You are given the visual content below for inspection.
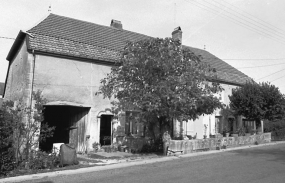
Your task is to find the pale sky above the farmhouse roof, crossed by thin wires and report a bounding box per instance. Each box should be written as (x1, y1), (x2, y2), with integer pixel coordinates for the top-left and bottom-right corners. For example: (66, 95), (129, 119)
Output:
(0, 0), (285, 94)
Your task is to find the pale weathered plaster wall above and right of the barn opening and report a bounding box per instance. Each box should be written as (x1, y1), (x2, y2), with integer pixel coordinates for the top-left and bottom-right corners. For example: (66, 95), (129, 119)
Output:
(31, 55), (111, 148)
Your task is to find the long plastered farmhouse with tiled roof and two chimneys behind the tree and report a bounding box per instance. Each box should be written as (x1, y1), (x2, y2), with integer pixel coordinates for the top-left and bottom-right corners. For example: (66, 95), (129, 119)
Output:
(3, 14), (251, 152)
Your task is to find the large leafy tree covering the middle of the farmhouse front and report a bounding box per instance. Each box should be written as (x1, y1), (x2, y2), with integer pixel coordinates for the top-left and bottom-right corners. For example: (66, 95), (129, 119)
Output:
(98, 38), (222, 136)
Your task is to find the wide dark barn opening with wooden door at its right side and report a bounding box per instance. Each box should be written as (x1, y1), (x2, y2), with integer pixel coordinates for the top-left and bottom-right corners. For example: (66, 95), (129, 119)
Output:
(39, 106), (90, 152)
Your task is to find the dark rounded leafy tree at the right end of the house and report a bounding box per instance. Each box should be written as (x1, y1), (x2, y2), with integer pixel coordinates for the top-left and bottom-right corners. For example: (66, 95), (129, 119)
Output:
(229, 82), (285, 121)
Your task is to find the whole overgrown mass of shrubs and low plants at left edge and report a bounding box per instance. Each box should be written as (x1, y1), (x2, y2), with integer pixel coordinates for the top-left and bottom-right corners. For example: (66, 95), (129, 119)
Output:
(0, 91), (57, 176)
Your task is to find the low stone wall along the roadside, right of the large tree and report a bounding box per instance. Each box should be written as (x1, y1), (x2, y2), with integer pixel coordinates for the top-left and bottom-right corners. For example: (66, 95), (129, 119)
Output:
(168, 133), (271, 154)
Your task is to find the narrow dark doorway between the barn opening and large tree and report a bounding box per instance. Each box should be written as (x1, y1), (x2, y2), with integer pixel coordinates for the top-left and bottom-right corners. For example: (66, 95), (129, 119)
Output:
(100, 115), (113, 145)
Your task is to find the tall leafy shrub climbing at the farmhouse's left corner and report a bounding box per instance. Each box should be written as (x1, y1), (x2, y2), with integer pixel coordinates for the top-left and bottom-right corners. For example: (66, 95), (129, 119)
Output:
(13, 90), (55, 163)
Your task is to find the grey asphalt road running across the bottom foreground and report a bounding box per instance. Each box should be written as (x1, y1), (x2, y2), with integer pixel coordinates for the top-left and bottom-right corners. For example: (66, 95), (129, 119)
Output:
(22, 144), (285, 183)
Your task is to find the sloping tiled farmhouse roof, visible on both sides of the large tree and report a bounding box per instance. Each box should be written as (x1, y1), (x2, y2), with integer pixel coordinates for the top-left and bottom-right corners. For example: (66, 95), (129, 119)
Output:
(27, 14), (250, 84)
